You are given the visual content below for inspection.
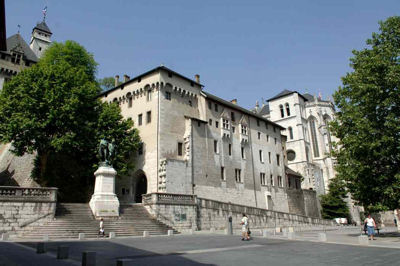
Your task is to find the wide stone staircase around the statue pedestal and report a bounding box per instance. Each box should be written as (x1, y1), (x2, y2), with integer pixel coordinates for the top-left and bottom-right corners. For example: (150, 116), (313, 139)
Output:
(18, 203), (178, 239)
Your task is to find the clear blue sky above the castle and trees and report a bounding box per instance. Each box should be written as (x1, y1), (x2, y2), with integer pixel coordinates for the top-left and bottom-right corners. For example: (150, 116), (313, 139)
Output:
(5, 0), (400, 108)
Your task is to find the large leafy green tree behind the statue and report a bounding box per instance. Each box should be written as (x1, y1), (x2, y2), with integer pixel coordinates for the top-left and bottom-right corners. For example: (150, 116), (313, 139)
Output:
(0, 41), (139, 201)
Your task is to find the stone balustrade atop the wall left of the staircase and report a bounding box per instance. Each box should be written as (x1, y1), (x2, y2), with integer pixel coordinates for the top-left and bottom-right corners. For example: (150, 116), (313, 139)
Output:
(0, 186), (57, 202)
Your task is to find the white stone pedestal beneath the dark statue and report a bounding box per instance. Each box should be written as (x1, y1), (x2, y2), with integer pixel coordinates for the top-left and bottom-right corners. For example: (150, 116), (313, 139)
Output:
(89, 166), (119, 217)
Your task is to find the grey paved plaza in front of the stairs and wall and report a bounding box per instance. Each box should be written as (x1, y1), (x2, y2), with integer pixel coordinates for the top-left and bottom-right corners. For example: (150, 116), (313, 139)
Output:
(0, 228), (400, 266)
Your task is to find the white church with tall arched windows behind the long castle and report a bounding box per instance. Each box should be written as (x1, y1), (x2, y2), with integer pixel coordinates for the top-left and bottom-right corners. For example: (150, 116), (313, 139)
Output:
(254, 90), (336, 194)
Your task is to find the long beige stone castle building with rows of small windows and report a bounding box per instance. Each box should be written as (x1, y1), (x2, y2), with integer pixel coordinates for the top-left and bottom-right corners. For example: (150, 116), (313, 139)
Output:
(100, 66), (320, 217)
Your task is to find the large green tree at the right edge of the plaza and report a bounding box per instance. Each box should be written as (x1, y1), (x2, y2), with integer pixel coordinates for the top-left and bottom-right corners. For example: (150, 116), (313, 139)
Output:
(331, 16), (400, 211)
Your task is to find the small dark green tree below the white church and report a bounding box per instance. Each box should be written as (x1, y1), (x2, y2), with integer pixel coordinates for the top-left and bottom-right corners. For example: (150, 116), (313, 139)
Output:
(320, 177), (350, 219)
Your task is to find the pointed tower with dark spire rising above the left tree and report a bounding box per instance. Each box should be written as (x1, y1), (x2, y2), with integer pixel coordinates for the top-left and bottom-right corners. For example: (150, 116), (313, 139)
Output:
(29, 19), (52, 58)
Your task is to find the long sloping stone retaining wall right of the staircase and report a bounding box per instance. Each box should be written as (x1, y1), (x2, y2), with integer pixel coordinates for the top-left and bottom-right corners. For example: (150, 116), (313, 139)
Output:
(143, 193), (333, 231)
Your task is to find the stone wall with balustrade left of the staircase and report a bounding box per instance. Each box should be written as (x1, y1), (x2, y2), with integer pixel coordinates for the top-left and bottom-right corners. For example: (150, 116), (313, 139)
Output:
(0, 187), (57, 232)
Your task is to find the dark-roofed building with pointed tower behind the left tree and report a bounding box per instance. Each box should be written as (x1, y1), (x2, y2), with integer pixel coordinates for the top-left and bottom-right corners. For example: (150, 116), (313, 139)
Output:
(0, 20), (52, 90)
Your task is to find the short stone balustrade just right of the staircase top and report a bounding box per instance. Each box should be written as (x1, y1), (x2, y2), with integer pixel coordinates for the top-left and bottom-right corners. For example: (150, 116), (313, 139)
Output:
(142, 193), (196, 205)
